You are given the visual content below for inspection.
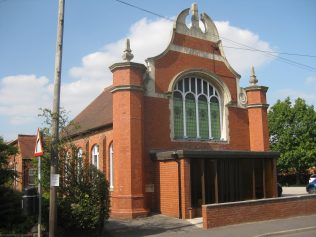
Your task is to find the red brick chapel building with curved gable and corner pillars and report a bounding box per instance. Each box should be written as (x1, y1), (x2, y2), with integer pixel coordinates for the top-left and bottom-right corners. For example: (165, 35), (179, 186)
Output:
(71, 3), (276, 218)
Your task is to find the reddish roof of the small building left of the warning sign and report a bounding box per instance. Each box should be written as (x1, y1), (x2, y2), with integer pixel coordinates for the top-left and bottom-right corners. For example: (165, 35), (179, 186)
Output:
(17, 134), (36, 159)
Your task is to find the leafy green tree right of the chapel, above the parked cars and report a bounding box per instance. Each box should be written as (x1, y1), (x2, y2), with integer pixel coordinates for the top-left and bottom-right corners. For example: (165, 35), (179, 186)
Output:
(268, 97), (316, 182)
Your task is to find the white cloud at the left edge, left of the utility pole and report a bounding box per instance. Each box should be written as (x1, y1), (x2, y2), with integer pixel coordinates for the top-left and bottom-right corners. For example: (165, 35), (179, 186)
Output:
(0, 75), (52, 125)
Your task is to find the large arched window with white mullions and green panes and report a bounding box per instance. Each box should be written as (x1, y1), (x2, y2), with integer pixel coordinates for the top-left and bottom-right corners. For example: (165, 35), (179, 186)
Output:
(173, 77), (222, 140)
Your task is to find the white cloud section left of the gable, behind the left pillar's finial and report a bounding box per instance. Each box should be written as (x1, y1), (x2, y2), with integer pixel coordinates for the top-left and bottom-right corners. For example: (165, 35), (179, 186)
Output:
(61, 18), (172, 115)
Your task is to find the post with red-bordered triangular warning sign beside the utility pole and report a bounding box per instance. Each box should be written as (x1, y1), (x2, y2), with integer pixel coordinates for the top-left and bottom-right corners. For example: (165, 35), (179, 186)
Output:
(34, 129), (43, 237)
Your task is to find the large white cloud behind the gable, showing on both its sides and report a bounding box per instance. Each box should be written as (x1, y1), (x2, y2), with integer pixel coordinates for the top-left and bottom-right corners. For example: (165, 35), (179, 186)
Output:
(62, 18), (272, 114)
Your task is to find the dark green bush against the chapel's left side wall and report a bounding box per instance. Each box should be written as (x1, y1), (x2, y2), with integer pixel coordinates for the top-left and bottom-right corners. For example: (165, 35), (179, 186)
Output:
(58, 164), (109, 231)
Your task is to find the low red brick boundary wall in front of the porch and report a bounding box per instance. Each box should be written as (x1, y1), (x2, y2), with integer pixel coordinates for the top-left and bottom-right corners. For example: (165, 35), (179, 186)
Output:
(202, 194), (316, 229)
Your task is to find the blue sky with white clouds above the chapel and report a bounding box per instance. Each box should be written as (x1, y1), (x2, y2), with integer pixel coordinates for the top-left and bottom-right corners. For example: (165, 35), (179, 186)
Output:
(0, 0), (316, 141)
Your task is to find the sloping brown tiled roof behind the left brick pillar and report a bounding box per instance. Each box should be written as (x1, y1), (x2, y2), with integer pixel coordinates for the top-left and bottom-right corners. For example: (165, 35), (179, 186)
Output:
(67, 86), (113, 136)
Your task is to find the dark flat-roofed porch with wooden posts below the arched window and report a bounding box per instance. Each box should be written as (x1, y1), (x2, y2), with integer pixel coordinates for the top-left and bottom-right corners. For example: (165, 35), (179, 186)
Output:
(151, 150), (280, 208)
